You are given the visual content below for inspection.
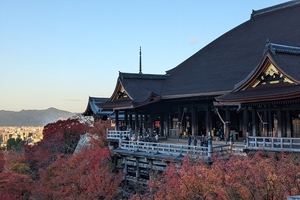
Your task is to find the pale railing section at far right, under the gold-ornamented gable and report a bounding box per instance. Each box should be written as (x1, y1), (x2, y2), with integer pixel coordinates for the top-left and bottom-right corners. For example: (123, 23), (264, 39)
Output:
(246, 136), (300, 152)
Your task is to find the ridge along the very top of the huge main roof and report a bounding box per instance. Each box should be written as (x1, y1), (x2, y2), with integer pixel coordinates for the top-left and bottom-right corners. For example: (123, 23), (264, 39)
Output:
(251, 0), (300, 19)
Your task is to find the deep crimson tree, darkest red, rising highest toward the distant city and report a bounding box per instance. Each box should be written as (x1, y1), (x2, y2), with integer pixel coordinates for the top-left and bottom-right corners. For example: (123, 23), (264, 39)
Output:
(24, 119), (87, 177)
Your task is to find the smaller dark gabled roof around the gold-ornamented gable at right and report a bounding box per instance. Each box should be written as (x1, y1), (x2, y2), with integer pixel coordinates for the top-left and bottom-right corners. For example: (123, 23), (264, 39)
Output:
(216, 41), (300, 102)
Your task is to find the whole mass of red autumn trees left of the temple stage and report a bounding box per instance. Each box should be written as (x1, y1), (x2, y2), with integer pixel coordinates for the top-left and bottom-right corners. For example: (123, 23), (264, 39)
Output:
(0, 119), (122, 200)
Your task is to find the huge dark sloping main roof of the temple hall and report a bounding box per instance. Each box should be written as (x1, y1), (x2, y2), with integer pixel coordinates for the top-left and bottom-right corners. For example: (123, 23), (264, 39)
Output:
(162, 1), (300, 98)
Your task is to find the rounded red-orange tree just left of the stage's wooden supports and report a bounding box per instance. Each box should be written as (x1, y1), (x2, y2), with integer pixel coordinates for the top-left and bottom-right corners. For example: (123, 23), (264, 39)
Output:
(33, 146), (122, 199)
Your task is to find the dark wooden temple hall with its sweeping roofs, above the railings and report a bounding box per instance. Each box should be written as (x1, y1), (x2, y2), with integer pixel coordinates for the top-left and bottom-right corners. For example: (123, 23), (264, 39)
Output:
(83, 0), (300, 142)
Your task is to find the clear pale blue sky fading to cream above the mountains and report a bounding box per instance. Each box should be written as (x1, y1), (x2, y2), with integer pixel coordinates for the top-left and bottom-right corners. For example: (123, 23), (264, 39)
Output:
(0, 0), (286, 112)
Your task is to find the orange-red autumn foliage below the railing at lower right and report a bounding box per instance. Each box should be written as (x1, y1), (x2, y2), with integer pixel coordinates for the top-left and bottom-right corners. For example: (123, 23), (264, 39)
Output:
(132, 152), (300, 200)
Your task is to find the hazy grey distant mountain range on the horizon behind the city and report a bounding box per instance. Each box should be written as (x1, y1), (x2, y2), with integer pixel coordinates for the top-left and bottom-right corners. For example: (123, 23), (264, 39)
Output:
(0, 108), (75, 126)
